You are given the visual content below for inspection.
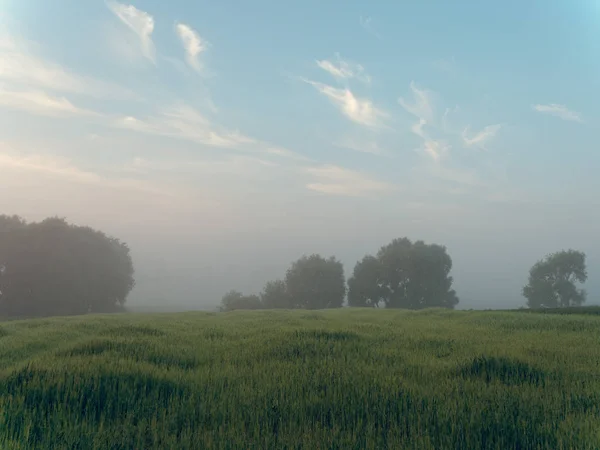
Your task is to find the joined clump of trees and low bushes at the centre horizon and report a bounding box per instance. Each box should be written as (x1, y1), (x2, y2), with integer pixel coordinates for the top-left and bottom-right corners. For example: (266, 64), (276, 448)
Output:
(221, 238), (459, 311)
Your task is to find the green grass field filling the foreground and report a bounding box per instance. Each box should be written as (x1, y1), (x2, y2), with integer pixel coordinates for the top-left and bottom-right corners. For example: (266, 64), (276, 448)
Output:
(0, 309), (600, 450)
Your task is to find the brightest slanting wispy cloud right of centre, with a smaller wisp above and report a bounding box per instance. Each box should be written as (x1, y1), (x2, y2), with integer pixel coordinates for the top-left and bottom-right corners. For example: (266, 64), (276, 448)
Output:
(303, 79), (388, 128)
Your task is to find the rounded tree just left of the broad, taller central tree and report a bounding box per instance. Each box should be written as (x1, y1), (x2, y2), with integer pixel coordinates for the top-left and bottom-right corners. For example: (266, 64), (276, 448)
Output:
(285, 254), (346, 309)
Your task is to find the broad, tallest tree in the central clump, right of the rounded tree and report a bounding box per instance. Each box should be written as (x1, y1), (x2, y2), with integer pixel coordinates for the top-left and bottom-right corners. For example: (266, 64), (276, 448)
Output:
(348, 238), (459, 309)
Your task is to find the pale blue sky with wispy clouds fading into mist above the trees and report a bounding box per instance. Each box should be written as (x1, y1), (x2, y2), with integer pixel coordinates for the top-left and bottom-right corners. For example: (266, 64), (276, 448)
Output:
(0, 0), (600, 308)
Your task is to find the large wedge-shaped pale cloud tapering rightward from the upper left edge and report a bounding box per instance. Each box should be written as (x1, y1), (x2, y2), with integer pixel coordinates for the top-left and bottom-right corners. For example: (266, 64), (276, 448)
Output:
(0, 34), (133, 98)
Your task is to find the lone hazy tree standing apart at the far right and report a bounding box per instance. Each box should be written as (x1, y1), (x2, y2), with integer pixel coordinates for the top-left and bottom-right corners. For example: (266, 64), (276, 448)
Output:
(523, 250), (587, 308)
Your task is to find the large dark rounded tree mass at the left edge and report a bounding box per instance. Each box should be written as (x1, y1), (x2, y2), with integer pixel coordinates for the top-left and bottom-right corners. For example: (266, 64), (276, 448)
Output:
(0, 216), (135, 317)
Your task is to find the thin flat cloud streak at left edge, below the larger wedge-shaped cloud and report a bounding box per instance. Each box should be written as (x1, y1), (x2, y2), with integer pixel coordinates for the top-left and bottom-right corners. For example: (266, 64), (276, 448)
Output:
(0, 86), (98, 117)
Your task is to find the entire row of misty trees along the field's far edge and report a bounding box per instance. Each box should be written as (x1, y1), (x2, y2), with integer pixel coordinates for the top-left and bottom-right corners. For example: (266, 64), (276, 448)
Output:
(0, 215), (587, 317)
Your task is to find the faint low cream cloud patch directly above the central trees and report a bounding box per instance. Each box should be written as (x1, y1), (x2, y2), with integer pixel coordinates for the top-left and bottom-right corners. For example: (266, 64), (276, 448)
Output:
(304, 165), (395, 197)
